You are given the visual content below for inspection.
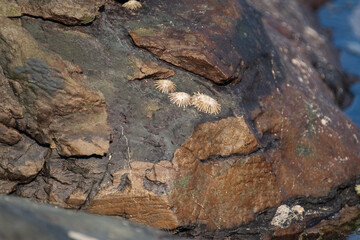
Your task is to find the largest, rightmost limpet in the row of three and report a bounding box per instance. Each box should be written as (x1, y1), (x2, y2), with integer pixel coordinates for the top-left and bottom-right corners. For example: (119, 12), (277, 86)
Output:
(191, 92), (221, 114)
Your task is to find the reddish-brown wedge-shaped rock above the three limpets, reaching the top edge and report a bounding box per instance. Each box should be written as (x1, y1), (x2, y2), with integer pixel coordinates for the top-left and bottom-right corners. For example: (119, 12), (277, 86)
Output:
(130, 0), (246, 83)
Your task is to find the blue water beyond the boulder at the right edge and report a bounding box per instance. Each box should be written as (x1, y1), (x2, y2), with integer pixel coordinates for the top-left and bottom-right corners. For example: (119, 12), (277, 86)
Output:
(319, 0), (360, 126)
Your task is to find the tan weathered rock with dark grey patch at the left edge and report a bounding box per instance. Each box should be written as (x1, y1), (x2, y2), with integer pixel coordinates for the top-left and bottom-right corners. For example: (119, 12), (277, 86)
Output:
(0, 15), (109, 157)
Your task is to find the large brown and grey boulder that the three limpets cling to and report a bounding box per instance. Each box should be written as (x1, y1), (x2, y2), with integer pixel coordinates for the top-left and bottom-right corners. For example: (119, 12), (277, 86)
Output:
(0, 0), (360, 239)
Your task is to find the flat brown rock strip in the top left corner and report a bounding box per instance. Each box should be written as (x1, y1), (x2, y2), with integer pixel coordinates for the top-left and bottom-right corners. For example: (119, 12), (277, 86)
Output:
(0, 0), (106, 25)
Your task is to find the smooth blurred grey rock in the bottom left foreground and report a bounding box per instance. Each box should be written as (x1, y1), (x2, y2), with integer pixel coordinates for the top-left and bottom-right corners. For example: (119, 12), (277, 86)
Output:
(0, 196), (174, 240)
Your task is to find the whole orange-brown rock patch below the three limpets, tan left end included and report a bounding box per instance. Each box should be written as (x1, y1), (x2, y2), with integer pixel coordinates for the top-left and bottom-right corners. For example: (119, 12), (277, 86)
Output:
(87, 117), (281, 230)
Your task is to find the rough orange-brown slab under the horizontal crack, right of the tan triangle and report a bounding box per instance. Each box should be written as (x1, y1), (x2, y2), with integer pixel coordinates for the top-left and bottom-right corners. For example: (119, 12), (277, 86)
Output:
(170, 153), (281, 230)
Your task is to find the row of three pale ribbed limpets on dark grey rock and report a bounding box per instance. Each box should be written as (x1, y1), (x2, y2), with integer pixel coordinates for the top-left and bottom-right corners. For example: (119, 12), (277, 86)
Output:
(155, 80), (221, 115)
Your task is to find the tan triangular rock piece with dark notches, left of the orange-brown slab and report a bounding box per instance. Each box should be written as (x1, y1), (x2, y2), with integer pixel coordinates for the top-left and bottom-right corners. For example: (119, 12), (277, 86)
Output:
(87, 162), (179, 229)
